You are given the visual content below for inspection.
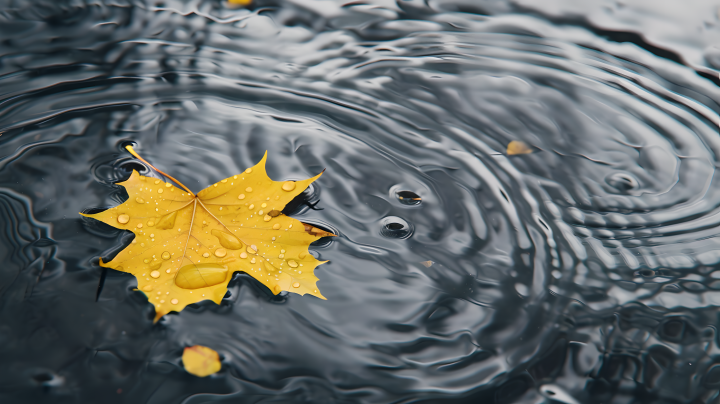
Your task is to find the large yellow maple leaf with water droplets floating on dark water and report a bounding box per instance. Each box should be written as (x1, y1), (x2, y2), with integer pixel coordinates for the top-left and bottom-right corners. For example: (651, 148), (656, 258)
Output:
(81, 146), (334, 321)
